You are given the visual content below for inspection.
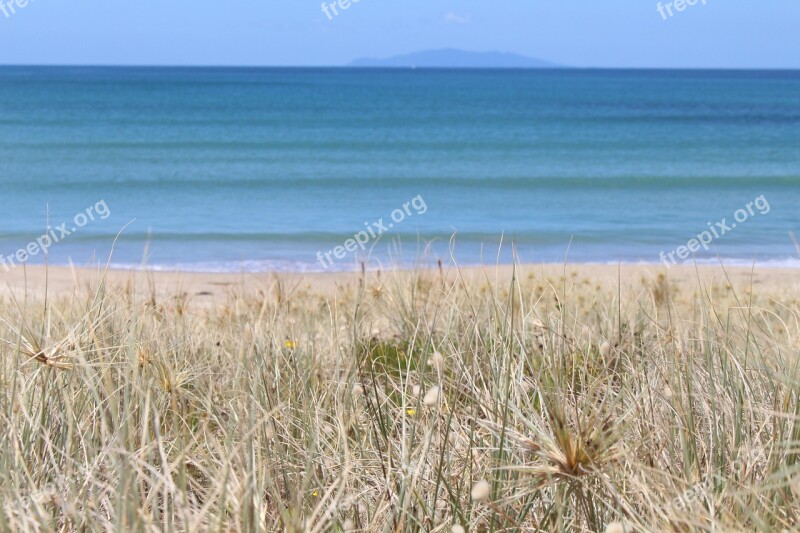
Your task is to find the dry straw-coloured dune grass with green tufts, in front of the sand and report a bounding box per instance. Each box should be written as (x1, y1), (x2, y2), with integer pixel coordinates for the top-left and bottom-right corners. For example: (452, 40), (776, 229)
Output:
(0, 268), (800, 532)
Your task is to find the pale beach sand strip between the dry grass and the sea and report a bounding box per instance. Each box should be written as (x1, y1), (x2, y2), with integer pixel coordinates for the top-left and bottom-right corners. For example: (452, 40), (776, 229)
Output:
(0, 264), (800, 306)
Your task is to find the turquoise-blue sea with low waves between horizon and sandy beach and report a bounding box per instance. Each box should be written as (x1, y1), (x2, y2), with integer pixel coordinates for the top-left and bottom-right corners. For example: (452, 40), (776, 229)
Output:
(0, 67), (800, 271)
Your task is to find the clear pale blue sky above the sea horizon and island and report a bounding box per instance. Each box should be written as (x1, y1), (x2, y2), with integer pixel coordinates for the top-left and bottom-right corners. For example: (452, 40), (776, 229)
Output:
(0, 0), (800, 68)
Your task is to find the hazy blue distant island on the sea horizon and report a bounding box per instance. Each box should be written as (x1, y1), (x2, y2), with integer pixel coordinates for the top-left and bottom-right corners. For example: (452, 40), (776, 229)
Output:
(348, 48), (563, 68)
